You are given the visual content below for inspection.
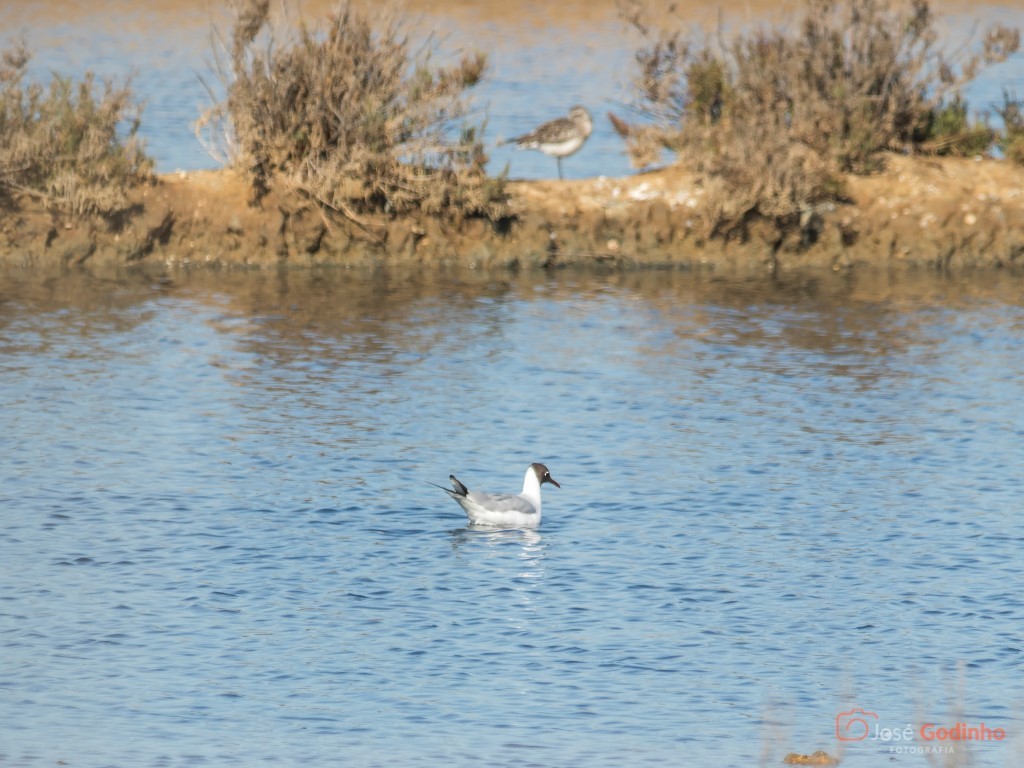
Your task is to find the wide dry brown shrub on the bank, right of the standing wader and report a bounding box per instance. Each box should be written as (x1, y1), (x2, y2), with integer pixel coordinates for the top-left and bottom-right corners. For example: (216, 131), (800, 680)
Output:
(620, 0), (1020, 236)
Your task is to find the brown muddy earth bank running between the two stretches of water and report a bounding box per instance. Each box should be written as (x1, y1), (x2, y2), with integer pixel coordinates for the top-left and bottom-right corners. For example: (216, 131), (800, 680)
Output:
(0, 156), (1024, 271)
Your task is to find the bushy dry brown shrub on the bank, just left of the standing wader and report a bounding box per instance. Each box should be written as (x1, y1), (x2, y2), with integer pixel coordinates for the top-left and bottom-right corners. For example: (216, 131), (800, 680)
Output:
(198, 0), (507, 221)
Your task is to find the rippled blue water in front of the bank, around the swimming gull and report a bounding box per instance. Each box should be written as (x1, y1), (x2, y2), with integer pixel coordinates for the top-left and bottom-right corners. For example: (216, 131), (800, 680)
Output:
(0, 271), (1024, 768)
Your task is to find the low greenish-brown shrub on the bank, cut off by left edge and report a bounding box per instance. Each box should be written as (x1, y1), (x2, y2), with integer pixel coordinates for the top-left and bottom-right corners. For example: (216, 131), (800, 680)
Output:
(0, 43), (153, 217)
